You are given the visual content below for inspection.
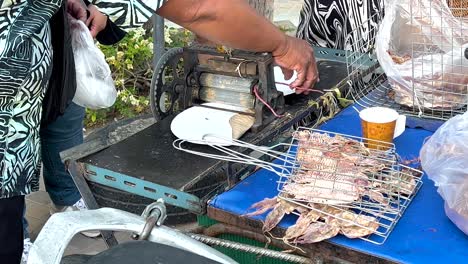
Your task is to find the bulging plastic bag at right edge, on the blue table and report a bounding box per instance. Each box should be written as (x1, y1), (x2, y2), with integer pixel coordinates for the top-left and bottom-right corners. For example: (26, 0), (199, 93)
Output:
(420, 112), (468, 235)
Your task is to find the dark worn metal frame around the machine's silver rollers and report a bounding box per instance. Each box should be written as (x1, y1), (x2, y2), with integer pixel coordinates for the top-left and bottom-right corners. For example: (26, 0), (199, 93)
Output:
(183, 45), (284, 133)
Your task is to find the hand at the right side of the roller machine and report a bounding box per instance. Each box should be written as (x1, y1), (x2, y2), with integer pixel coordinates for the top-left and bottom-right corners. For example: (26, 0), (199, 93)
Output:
(272, 36), (319, 94)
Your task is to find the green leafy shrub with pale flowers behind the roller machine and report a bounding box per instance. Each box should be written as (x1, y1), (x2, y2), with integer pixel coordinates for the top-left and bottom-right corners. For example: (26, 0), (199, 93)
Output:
(85, 27), (193, 128)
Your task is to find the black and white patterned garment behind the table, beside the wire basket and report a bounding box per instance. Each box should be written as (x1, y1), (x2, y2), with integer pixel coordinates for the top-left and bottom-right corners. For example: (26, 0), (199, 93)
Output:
(297, 0), (384, 52)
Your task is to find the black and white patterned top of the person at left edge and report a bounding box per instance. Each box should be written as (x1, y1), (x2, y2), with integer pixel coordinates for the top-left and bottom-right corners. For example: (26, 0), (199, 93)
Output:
(0, 0), (164, 198)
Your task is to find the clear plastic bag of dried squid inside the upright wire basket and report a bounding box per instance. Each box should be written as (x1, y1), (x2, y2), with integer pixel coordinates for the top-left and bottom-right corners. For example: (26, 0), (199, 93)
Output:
(376, 0), (468, 109)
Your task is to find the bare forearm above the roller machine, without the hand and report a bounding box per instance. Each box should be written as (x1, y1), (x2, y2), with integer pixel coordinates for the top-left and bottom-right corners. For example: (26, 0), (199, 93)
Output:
(160, 0), (287, 62)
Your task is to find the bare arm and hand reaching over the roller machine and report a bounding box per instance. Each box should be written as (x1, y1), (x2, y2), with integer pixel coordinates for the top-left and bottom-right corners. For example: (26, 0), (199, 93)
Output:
(156, 0), (318, 92)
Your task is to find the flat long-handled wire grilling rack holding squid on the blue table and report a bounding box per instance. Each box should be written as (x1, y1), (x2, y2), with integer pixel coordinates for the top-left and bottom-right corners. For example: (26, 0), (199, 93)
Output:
(173, 127), (422, 244)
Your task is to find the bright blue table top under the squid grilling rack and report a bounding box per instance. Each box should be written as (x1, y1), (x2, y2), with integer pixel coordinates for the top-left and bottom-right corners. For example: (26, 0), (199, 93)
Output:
(209, 104), (468, 263)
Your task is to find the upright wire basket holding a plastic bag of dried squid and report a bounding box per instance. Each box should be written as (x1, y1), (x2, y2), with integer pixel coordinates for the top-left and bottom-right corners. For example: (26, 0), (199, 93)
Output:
(346, 0), (468, 120)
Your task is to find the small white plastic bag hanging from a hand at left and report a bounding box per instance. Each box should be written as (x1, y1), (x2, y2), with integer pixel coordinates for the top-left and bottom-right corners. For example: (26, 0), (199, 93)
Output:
(70, 19), (117, 109)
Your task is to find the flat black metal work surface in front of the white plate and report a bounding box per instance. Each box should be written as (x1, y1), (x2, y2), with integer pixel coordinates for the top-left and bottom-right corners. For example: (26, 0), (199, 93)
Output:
(81, 117), (221, 189)
